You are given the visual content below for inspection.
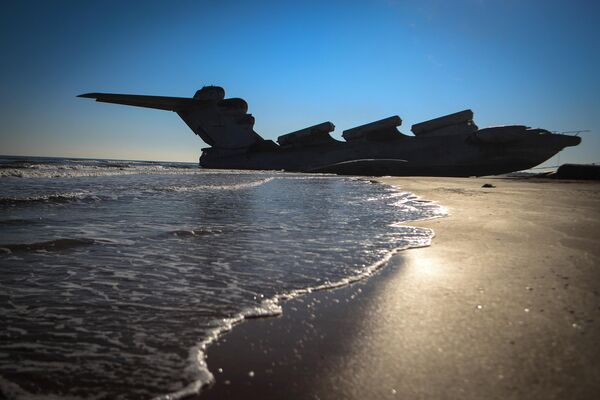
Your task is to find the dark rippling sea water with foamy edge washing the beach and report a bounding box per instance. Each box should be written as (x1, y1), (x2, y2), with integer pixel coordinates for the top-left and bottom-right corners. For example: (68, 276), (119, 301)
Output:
(0, 157), (444, 399)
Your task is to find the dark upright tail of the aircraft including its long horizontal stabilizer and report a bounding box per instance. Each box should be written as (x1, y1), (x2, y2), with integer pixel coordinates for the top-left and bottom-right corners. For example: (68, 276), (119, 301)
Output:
(78, 86), (264, 149)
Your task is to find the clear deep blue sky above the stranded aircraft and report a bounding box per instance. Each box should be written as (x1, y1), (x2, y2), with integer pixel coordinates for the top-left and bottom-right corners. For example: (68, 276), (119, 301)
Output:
(0, 0), (600, 164)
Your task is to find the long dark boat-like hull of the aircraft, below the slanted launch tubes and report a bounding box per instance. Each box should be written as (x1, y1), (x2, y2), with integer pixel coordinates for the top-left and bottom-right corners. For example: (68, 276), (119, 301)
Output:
(200, 126), (581, 176)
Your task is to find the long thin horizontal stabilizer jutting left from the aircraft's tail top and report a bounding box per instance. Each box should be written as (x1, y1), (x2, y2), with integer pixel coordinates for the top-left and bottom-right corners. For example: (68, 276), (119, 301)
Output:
(77, 93), (197, 111)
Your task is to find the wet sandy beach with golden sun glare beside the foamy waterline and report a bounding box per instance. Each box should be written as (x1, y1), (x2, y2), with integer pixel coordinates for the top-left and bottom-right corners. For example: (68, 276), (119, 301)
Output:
(199, 178), (600, 399)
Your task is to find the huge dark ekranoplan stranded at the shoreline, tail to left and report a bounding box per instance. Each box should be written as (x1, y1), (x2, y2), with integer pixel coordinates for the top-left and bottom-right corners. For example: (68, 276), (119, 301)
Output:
(79, 86), (581, 176)
